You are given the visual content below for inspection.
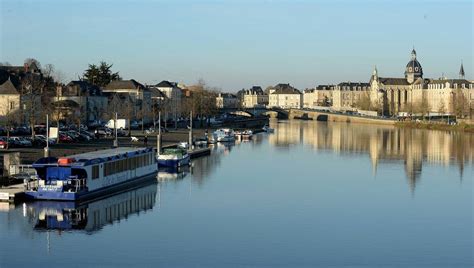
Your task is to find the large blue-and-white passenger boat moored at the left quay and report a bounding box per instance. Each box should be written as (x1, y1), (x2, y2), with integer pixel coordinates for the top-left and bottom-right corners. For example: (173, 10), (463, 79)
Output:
(25, 147), (158, 201)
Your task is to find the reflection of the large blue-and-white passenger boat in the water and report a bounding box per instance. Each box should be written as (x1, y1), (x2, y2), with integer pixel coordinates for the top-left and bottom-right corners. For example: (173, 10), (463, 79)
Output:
(27, 181), (157, 232)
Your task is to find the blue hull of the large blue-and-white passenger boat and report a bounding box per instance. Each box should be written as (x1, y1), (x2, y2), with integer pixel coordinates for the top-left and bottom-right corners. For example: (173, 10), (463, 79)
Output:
(25, 172), (156, 201)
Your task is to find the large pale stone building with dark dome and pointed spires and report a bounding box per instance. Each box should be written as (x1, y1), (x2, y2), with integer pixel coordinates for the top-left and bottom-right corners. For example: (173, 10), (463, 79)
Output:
(369, 49), (474, 117)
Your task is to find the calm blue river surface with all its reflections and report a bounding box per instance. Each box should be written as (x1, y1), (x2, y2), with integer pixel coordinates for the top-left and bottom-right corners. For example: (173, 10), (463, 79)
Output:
(0, 121), (474, 267)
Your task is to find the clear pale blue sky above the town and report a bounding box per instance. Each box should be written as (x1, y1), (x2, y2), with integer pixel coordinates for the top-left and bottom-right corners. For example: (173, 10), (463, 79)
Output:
(0, 0), (474, 92)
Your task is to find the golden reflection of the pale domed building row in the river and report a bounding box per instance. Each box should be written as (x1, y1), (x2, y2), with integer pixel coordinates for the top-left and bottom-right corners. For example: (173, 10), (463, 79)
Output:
(269, 120), (474, 192)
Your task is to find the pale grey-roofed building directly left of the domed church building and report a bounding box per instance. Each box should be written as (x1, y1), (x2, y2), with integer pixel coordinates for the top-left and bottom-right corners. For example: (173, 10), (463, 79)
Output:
(333, 82), (370, 110)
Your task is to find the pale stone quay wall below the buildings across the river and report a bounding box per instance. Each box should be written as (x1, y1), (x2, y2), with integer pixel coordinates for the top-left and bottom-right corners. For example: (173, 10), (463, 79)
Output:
(288, 109), (397, 125)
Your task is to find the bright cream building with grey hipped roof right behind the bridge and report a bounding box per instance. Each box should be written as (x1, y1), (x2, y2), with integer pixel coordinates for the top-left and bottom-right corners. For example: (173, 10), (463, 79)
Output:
(268, 84), (303, 109)
